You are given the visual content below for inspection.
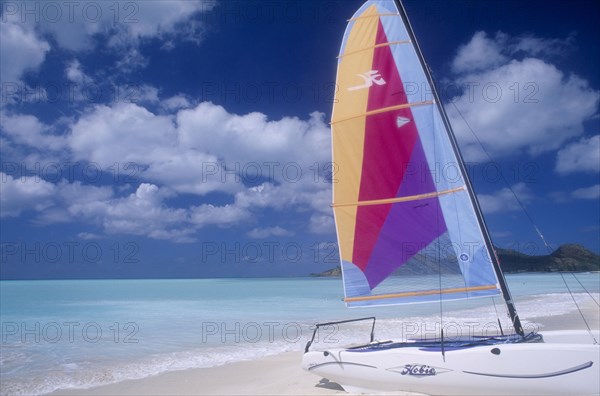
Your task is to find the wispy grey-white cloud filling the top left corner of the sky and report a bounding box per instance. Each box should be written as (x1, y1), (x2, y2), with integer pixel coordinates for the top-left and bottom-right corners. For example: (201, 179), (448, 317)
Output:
(0, 0), (216, 83)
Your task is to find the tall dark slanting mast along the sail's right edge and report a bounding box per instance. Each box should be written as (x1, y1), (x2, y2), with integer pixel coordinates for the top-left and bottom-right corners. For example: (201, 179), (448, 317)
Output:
(394, 0), (525, 336)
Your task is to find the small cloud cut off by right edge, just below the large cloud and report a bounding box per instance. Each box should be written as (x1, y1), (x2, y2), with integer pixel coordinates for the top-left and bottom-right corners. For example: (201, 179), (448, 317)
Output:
(556, 135), (600, 175)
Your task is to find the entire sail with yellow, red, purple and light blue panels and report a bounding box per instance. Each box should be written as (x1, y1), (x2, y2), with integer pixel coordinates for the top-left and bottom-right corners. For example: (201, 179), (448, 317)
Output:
(331, 0), (499, 306)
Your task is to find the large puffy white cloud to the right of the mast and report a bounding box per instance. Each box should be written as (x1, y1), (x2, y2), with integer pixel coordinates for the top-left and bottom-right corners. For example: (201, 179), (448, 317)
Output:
(446, 32), (600, 161)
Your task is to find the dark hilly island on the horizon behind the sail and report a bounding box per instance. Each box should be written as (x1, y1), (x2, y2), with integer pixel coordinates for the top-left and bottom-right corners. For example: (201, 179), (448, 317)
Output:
(310, 244), (600, 277)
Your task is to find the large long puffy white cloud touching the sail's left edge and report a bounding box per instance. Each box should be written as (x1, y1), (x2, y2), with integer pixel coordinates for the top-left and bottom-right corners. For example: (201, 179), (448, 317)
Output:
(67, 102), (330, 200)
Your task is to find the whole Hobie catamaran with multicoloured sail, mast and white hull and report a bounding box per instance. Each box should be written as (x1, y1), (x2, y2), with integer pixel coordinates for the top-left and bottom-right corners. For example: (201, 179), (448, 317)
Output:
(302, 0), (600, 395)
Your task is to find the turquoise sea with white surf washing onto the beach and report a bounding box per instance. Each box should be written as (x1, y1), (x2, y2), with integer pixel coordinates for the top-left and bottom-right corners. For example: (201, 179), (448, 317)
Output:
(0, 273), (600, 395)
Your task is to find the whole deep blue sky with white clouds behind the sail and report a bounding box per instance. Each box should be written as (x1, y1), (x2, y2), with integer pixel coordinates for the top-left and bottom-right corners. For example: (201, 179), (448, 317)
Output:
(0, 0), (600, 279)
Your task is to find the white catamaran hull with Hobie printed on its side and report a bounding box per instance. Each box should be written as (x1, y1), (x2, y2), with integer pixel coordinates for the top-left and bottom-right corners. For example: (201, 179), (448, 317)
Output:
(302, 331), (600, 396)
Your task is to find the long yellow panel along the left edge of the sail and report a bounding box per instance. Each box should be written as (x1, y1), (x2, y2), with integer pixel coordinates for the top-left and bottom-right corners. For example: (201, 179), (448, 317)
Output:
(331, 6), (379, 260)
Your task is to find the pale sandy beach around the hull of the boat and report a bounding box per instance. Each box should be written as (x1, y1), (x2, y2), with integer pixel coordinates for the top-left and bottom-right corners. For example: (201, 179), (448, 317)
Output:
(52, 302), (600, 395)
